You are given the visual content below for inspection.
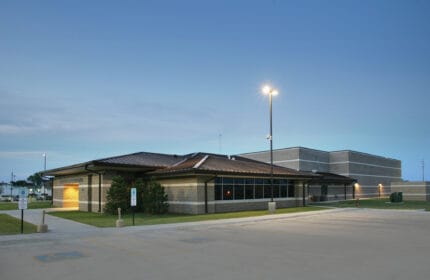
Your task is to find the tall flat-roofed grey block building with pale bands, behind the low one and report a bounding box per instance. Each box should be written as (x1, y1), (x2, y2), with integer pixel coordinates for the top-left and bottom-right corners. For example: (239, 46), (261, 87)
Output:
(240, 147), (402, 200)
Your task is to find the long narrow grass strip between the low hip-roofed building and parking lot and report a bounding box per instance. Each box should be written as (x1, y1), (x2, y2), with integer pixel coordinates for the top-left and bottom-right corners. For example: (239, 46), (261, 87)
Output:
(49, 206), (325, 227)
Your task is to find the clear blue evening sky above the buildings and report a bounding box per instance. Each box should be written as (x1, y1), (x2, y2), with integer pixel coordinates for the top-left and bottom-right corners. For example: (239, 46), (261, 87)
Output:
(0, 0), (430, 181)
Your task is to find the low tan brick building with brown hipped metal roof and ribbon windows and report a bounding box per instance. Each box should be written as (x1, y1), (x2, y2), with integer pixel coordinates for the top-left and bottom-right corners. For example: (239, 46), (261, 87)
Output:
(43, 152), (354, 214)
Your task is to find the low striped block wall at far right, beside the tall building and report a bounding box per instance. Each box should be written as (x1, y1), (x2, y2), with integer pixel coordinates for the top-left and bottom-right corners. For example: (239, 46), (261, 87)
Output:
(391, 182), (430, 201)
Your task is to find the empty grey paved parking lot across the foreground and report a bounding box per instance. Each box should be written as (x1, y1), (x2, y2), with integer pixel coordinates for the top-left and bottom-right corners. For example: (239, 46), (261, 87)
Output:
(0, 209), (430, 280)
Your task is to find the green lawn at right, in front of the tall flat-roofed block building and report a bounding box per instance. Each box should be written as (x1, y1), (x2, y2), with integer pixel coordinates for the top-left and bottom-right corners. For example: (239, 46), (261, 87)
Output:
(312, 198), (430, 211)
